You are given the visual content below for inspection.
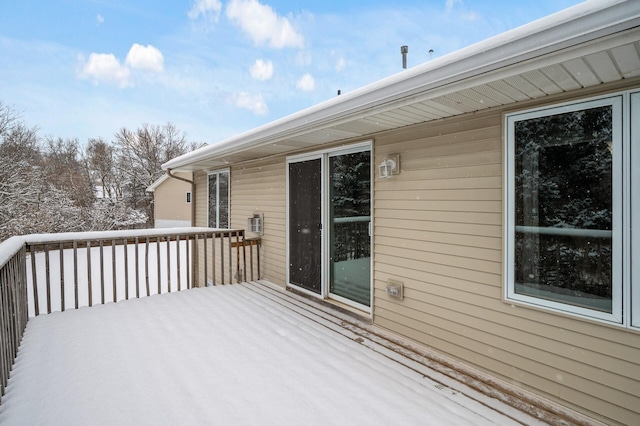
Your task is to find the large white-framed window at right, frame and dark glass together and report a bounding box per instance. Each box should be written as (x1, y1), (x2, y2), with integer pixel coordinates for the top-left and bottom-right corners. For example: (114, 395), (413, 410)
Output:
(505, 93), (640, 326)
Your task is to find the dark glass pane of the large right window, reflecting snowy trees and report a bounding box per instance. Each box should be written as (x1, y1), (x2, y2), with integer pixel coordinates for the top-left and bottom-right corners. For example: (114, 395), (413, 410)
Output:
(514, 106), (613, 312)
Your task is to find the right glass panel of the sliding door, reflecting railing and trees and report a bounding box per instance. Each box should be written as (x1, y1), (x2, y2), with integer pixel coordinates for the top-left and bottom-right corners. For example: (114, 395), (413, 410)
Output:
(329, 151), (371, 306)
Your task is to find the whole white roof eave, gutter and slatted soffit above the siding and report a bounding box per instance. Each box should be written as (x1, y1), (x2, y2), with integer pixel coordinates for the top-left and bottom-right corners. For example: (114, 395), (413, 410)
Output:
(162, 0), (640, 171)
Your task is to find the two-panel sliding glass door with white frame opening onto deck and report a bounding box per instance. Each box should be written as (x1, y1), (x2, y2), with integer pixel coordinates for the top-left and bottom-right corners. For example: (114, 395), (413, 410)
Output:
(288, 143), (371, 308)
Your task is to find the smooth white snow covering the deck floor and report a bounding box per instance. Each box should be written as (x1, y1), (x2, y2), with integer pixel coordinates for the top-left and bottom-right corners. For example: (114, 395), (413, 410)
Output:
(0, 284), (528, 425)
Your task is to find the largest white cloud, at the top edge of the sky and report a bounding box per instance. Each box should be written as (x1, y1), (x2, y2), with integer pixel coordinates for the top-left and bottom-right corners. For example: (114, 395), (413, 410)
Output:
(227, 0), (304, 49)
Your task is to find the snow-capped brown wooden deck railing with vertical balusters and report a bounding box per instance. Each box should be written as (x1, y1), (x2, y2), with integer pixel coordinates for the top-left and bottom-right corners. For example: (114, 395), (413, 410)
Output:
(0, 228), (260, 396)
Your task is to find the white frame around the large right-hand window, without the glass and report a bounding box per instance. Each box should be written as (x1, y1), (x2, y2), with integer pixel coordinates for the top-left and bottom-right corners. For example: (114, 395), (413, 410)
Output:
(504, 93), (624, 326)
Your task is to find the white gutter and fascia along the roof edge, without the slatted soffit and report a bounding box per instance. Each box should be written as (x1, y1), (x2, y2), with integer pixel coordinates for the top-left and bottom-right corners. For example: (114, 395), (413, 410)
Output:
(162, 0), (640, 171)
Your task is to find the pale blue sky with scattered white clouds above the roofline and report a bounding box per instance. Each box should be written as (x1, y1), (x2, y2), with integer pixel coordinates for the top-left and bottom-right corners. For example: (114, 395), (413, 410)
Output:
(0, 0), (579, 144)
